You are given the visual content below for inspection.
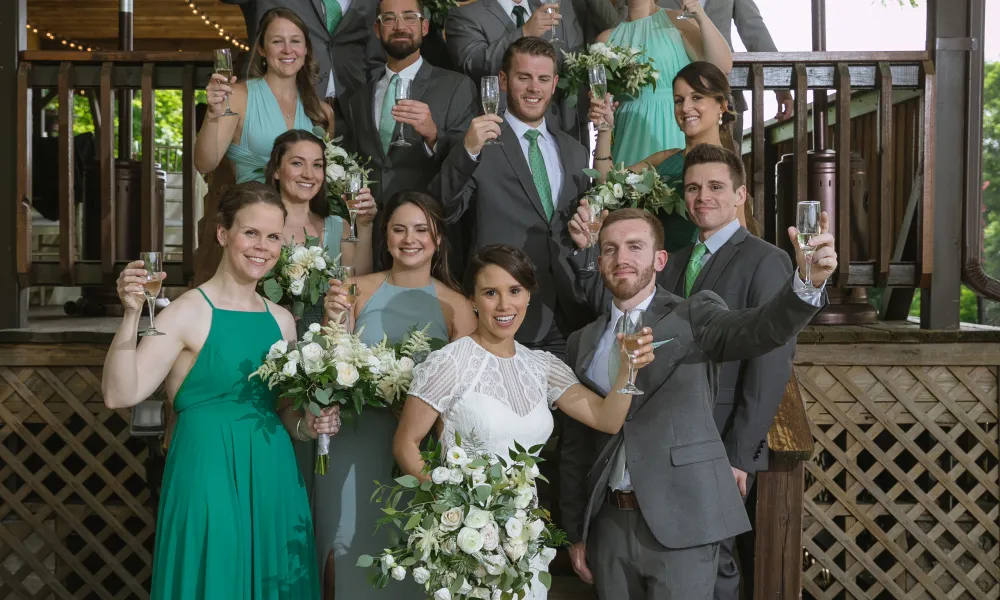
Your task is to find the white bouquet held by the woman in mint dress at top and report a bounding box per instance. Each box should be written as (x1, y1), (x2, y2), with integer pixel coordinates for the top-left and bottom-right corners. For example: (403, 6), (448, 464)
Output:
(559, 42), (660, 105)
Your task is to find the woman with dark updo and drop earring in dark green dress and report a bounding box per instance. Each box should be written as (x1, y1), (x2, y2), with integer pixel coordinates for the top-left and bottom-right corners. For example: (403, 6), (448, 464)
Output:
(590, 61), (756, 252)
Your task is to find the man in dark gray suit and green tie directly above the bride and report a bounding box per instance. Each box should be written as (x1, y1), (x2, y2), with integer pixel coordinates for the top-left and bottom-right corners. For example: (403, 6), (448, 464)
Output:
(430, 37), (593, 356)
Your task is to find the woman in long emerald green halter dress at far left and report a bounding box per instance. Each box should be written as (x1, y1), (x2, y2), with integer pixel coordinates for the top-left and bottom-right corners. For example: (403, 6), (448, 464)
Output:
(103, 182), (338, 600)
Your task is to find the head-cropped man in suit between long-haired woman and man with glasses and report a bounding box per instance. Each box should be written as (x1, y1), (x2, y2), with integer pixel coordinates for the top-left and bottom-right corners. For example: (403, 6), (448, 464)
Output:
(222, 0), (385, 119)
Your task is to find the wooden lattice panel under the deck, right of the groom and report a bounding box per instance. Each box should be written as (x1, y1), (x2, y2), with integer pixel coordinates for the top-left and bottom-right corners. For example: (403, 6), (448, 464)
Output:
(797, 361), (1000, 600)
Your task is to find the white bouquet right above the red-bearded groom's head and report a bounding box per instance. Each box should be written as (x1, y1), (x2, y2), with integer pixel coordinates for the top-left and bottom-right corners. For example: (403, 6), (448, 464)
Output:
(583, 164), (687, 218)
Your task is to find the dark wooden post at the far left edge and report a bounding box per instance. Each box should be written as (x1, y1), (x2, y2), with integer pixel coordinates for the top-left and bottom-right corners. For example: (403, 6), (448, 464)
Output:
(0, 0), (31, 329)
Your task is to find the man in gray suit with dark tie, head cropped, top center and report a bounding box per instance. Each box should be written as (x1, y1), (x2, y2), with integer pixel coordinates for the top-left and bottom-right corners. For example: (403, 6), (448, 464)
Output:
(445, 0), (619, 141)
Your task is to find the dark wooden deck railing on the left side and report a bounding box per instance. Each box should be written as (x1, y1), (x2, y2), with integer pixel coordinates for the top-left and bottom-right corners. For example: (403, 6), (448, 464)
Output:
(17, 51), (212, 286)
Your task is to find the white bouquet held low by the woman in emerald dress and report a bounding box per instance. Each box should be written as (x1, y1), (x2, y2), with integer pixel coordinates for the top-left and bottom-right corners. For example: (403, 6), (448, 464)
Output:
(250, 323), (444, 475)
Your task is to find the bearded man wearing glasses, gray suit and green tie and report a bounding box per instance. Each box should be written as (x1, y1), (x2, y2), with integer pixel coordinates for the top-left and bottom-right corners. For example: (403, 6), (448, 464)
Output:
(341, 0), (477, 267)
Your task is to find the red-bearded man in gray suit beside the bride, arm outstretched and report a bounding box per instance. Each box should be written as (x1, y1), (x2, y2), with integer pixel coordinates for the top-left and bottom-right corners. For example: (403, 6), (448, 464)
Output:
(564, 203), (837, 600)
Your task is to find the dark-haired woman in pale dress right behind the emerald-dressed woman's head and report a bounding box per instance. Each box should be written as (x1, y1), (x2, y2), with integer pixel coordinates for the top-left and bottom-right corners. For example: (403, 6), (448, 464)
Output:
(265, 129), (377, 498)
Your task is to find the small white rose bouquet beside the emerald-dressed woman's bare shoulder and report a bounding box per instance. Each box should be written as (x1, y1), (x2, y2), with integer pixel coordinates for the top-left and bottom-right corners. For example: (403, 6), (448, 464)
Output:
(257, 235), (339, 317)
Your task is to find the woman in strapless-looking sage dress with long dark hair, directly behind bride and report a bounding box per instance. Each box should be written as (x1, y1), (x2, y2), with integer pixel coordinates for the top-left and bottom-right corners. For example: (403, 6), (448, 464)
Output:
(313, 191), (476, 600)
